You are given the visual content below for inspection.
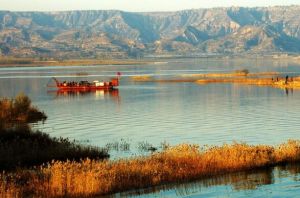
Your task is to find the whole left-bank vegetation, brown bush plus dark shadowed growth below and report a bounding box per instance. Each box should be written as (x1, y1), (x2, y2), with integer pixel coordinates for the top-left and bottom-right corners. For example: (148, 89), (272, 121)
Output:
(0, 94), (109, 170)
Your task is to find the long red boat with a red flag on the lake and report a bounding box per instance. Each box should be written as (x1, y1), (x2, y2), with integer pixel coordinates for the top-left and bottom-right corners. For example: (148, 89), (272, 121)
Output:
(49, 72), (121, 91)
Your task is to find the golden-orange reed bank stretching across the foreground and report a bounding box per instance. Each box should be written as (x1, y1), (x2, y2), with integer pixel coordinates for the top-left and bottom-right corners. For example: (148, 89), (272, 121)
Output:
(0, 140), (300, 196)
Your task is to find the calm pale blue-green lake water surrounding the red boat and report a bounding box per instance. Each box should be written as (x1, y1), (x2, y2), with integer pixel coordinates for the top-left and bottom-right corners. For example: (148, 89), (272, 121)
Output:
(0, 59), (300, 197)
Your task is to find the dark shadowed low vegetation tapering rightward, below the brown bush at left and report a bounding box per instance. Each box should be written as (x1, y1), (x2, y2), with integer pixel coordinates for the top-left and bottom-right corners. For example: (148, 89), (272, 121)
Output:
(0, 127), (109, 170)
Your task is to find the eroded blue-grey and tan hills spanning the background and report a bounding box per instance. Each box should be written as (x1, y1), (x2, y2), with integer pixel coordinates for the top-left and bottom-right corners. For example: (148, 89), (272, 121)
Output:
(0, 6), (300, 58)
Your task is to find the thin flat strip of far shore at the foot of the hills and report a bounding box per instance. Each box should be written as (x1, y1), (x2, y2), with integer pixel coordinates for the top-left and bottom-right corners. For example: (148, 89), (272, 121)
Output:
(0, 54), (300, 68)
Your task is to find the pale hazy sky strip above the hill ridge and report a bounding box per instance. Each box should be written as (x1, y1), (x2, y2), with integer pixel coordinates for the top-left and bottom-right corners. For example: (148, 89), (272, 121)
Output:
(0, 0), (300, 12)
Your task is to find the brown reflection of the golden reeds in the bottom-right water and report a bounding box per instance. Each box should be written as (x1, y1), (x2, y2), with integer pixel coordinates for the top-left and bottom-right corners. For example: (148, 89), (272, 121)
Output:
(114, 163), (300, 197)
